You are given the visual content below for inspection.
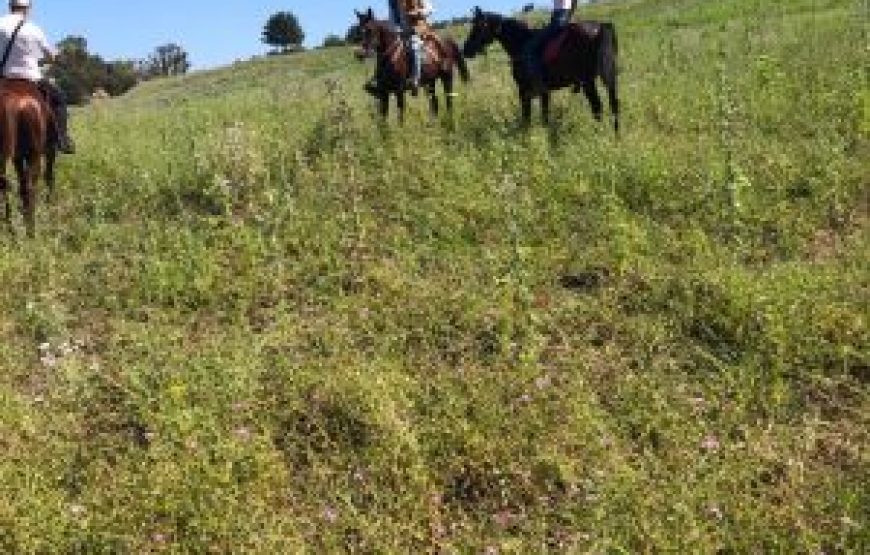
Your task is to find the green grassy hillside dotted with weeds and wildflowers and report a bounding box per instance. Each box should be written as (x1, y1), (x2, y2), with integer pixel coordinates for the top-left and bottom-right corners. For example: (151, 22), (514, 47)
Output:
(0, 0), (870, 553)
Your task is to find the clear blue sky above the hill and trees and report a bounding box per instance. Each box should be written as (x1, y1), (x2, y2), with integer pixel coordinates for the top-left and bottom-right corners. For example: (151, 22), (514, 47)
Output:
(32, 0), (524, 69)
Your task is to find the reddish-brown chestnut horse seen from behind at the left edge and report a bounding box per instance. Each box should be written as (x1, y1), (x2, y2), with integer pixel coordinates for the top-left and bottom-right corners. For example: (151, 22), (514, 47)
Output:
(0, 79), (57, 237)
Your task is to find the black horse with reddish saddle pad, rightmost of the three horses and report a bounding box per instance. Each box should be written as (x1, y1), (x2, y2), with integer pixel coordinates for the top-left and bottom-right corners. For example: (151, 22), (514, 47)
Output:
(463, 8), (619, 133)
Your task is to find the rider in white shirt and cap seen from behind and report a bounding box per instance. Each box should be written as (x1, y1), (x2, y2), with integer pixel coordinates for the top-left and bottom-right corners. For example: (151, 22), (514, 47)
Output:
(0, 0), (75, 154)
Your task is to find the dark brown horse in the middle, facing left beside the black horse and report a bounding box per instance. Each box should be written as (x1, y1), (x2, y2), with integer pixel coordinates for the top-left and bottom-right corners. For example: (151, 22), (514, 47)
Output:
(356, 9), (470, 121)
